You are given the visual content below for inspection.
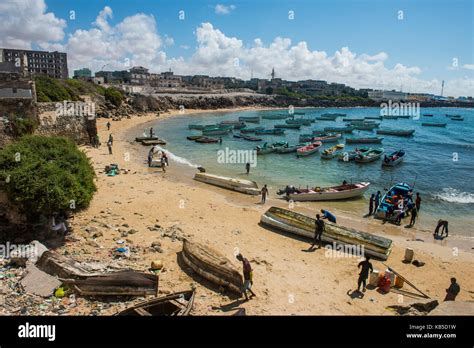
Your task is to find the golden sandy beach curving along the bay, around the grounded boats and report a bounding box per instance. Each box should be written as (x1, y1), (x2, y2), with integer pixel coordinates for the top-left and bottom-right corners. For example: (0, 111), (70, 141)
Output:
(60, 109), (474, 315)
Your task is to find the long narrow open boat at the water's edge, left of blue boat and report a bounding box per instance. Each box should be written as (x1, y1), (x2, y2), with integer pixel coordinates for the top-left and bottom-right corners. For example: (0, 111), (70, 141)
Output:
(287, 182), (370, 201)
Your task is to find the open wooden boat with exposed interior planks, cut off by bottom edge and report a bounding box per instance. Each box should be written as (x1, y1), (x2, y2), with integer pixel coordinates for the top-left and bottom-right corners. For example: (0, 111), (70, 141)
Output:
(115, 290), (195, 317)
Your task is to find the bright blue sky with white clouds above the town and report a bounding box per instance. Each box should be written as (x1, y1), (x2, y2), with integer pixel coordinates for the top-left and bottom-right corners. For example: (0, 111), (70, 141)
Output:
(0, 0), (474, 96)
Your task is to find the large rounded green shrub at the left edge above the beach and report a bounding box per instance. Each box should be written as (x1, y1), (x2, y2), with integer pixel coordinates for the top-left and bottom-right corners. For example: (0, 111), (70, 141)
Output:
(0, 135), (96, 221)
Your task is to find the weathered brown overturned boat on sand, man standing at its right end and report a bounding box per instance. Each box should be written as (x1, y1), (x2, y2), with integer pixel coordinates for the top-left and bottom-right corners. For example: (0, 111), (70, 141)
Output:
(181, 239), (243, 294)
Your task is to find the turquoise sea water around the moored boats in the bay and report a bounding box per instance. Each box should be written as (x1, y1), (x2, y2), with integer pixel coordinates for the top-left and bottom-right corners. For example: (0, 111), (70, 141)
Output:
(142, 108), (474, 236)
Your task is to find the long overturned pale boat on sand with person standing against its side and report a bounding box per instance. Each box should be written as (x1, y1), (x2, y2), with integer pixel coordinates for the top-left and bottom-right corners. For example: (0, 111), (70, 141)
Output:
(260, 207), (392, 260)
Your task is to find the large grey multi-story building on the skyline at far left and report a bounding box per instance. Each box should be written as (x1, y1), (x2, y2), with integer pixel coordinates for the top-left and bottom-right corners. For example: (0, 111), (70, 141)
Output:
(0, 48), (68, 79)
